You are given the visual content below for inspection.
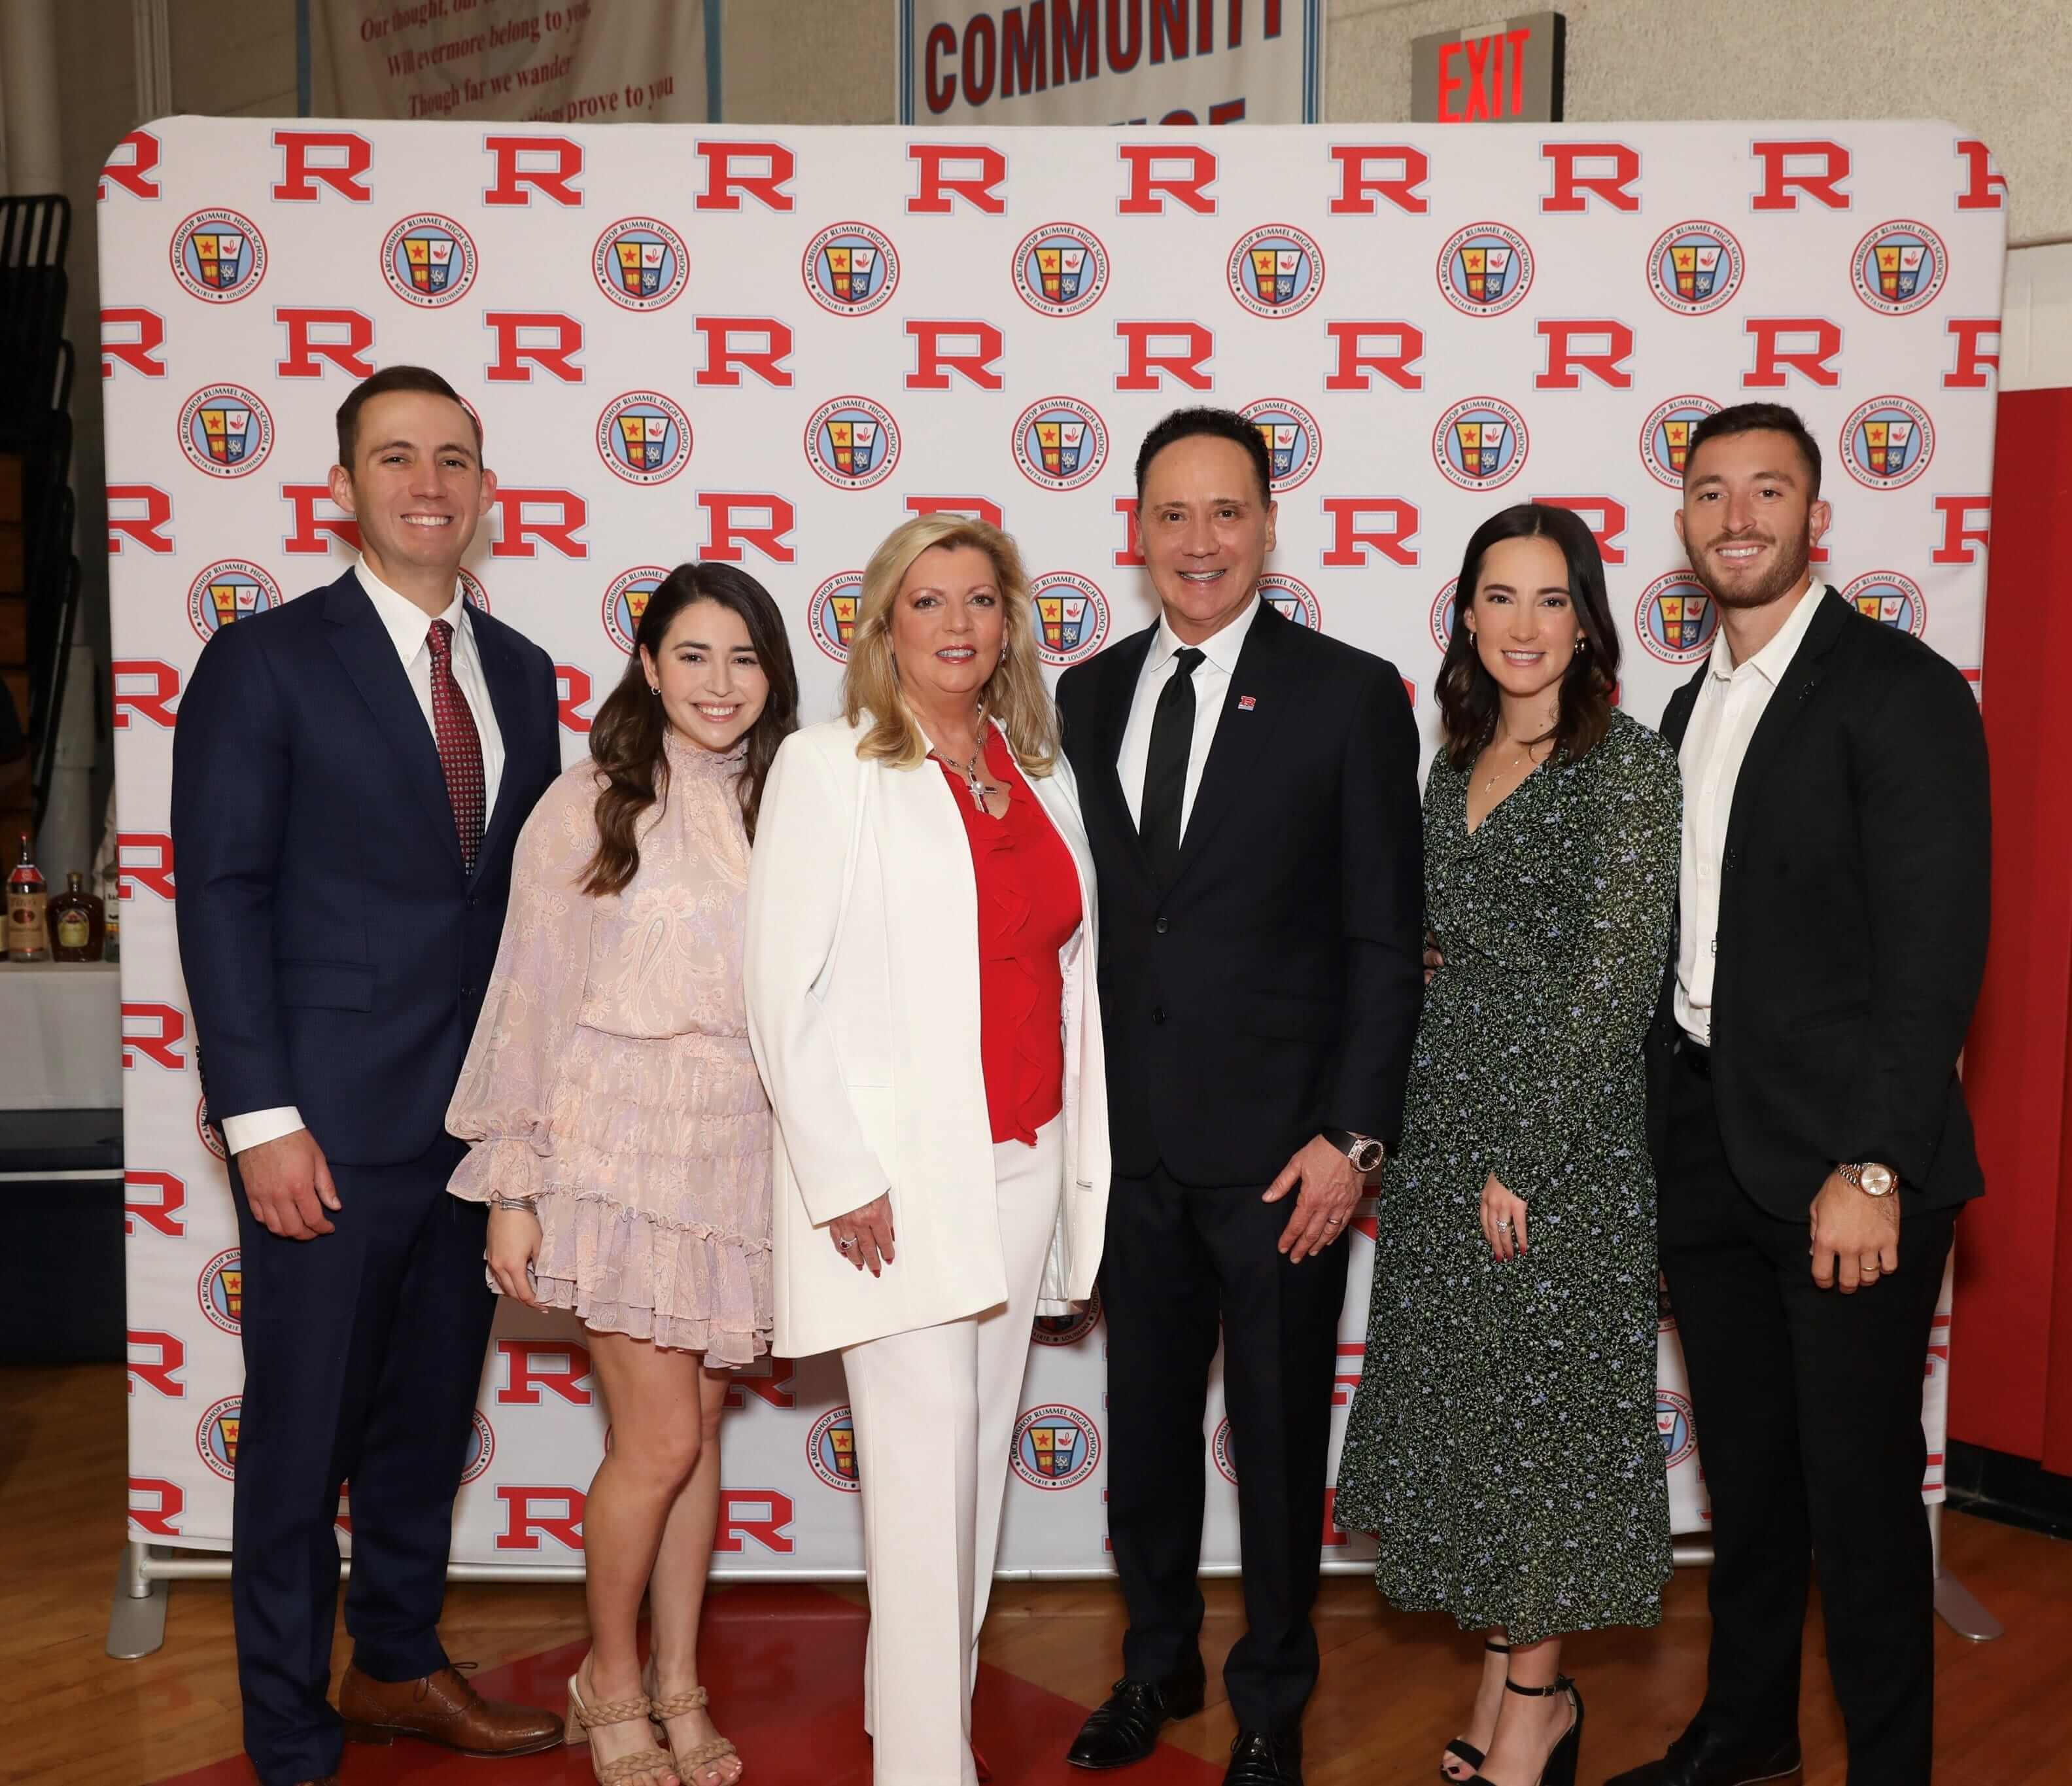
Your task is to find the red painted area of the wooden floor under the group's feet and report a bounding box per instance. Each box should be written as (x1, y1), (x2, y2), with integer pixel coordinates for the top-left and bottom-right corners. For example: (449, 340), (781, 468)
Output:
(158, 1585), (1222, 1786)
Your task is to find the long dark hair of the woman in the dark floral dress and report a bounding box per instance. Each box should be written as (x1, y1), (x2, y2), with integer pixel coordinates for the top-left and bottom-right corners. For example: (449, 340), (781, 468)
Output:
(1438, 501), (1618, 769)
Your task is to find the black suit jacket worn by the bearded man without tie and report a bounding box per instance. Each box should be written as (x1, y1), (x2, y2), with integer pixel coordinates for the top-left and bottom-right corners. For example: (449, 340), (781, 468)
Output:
(1648, 588), (1991, 1220)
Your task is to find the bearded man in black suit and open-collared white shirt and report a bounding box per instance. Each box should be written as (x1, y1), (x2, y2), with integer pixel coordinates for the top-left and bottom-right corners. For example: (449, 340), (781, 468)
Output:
(1614, 404), (1989, 1786)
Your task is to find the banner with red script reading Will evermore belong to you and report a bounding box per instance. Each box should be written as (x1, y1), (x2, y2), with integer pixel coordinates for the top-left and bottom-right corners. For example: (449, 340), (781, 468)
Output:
(309, 0), (704, 124)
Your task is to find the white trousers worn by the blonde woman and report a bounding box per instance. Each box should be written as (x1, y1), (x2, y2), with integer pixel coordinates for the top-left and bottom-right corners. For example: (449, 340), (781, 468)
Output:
(841, 1119), (1065, 1786)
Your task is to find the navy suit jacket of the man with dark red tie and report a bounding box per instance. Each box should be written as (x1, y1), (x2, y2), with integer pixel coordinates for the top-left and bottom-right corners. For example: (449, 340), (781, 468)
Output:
(172, 570), (562, 1164)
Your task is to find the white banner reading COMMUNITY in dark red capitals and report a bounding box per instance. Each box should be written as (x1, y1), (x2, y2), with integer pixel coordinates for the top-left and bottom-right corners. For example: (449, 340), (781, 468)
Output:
(899, 0), (1324, 131)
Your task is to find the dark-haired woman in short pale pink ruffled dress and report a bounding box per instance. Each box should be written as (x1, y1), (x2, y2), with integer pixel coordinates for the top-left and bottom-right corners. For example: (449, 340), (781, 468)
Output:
(445, 563), (798, 1786)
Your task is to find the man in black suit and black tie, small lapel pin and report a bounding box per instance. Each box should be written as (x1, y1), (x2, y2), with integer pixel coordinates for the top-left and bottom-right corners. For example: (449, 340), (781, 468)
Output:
(1057, 408), (1423, 1786)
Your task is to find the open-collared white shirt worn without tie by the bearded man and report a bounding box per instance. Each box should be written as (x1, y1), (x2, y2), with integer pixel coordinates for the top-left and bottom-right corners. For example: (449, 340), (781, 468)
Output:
(1676, 582), (1825, 1049)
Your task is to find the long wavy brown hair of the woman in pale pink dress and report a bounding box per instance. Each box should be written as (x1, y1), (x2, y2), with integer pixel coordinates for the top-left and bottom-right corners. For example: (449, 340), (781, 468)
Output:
(582, 563), (798, 895)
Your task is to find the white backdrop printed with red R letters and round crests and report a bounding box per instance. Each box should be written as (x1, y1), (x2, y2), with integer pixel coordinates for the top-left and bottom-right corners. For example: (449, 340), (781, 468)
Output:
(101, 118), (2003, 1573)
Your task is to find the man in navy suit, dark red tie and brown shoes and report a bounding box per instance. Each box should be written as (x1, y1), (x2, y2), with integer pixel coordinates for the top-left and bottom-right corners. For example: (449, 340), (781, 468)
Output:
(172, 367), (562, 1786)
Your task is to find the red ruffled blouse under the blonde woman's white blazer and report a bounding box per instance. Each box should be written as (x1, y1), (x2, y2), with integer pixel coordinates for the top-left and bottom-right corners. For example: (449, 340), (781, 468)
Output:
(939, 725), (1082, 1146)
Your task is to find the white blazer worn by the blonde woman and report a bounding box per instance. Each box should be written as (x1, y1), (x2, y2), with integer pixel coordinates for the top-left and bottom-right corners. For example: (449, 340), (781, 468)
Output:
(746, 719), (1109, 1357)
